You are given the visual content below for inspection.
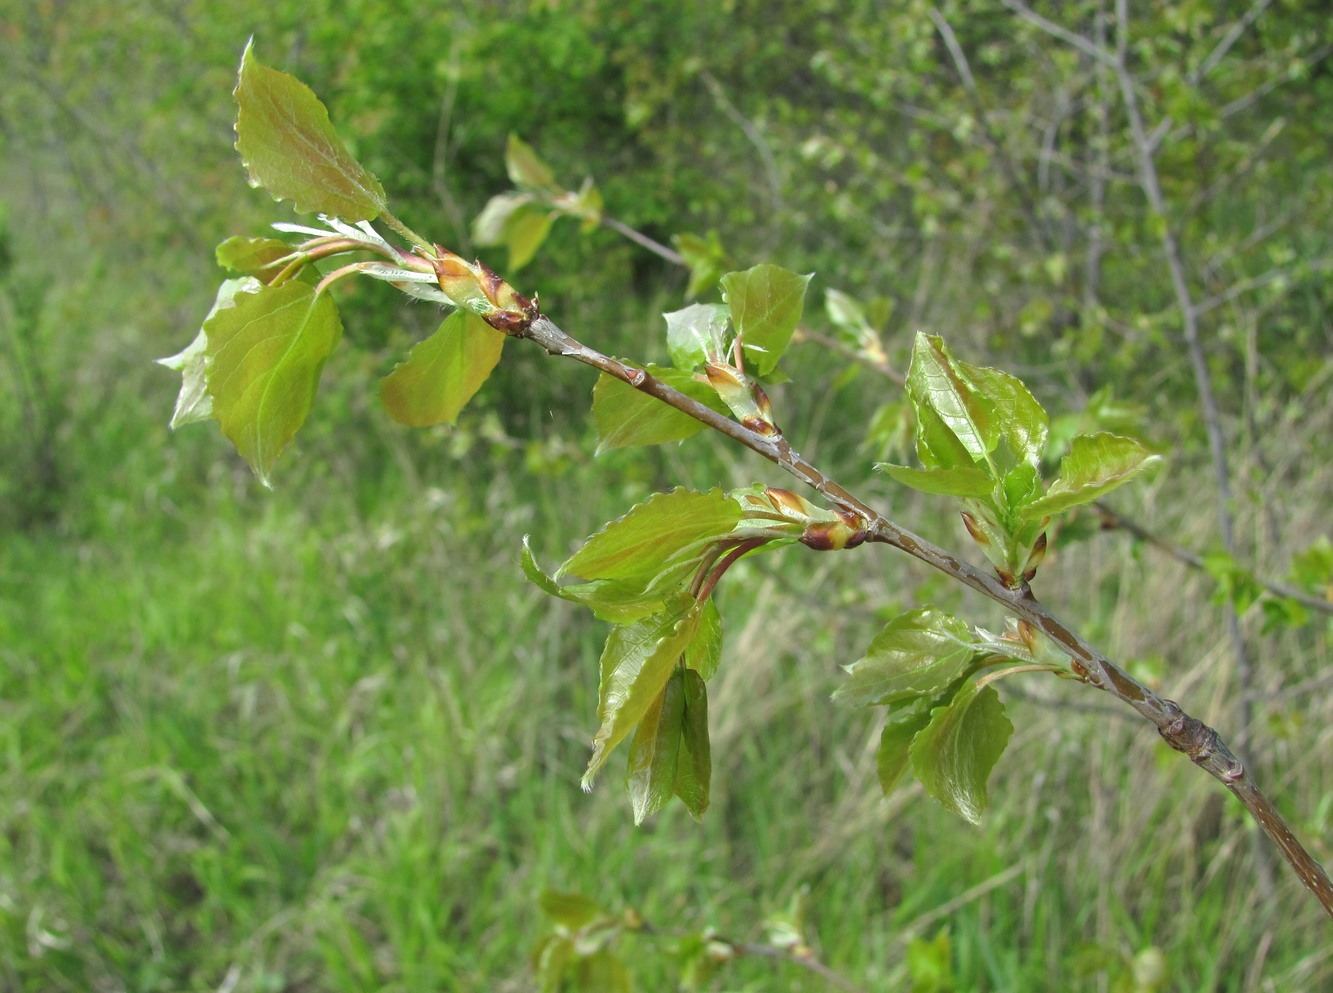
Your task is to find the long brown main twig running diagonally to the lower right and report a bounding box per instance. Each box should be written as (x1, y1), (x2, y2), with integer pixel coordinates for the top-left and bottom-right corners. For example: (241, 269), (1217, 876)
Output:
(500, 309), (1333, 918)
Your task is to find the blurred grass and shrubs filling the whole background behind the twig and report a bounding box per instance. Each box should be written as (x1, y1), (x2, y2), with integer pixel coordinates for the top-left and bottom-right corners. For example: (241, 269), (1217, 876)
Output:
(0, 0), (1333, 990)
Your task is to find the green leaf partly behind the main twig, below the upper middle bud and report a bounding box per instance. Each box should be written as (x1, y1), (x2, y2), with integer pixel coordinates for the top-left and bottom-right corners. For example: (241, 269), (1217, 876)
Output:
(592, 365), (726, 453)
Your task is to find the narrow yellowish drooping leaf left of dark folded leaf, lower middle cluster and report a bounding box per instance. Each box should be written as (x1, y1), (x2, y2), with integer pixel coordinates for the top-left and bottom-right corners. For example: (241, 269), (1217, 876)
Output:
(583, 594), (701, 789)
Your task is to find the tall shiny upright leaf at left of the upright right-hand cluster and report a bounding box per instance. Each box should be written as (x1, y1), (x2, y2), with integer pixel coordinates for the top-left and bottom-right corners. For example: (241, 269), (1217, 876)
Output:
(906, 333), (997, 469)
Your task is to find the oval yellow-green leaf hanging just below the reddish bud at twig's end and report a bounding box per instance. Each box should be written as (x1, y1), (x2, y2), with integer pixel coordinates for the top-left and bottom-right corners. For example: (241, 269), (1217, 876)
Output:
(380, 311), (505, 428)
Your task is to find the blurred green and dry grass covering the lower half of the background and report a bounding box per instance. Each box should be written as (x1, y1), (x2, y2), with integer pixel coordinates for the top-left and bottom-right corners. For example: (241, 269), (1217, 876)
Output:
(0, 359), (1333, 990)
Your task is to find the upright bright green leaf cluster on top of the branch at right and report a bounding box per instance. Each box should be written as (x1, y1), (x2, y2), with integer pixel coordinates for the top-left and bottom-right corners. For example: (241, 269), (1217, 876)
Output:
(878, 333), (1161, 585)
